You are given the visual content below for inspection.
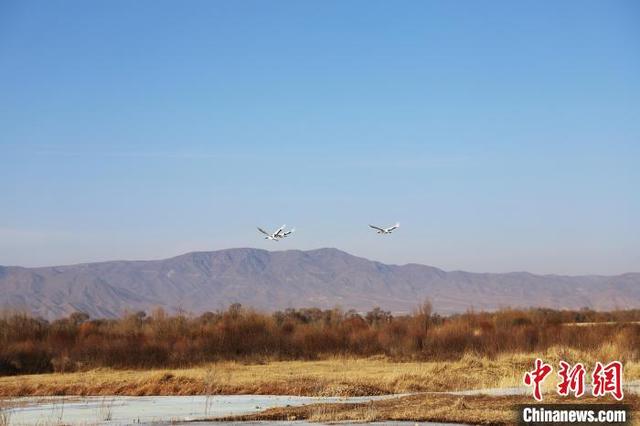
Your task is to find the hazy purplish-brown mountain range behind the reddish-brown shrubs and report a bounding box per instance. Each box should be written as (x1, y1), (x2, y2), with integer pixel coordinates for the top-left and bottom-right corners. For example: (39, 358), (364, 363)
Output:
(0, 248), (640, 319)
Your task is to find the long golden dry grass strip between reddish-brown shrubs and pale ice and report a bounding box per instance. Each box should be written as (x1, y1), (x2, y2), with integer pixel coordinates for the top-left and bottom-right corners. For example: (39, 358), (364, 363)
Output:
(0, 349), (640, 397)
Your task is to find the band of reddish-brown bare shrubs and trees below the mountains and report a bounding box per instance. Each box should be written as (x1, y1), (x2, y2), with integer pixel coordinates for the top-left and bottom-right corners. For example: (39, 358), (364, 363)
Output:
(0, 303), (640, 375)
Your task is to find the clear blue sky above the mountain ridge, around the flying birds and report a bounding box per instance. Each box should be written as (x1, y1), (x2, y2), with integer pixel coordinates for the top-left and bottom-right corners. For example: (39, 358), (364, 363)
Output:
(0, 0), (640, 274)
